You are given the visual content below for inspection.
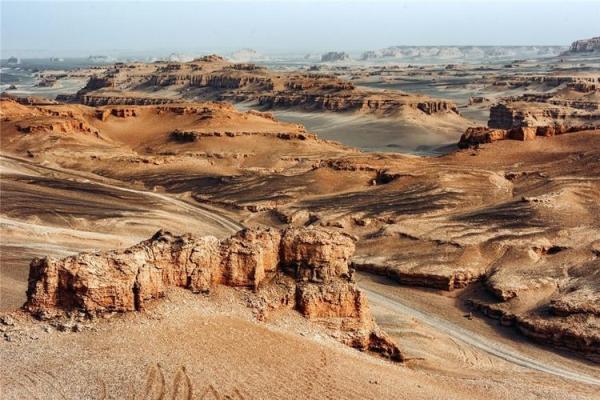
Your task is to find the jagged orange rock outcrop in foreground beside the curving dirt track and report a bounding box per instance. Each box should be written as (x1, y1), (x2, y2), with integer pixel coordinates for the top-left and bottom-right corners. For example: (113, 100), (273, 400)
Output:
(23, 228), (402, 360)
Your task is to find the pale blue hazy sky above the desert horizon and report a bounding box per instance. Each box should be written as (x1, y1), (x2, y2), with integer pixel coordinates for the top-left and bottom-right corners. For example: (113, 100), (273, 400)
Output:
(0, 0), (600, 57)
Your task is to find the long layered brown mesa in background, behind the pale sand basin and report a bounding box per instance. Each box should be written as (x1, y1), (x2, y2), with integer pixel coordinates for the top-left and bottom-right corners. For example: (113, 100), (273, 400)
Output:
(71, 57), (459, 117)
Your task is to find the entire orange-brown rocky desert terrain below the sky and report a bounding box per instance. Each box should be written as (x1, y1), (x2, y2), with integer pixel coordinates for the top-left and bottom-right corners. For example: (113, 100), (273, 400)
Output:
(0, 3), (600, 400)
